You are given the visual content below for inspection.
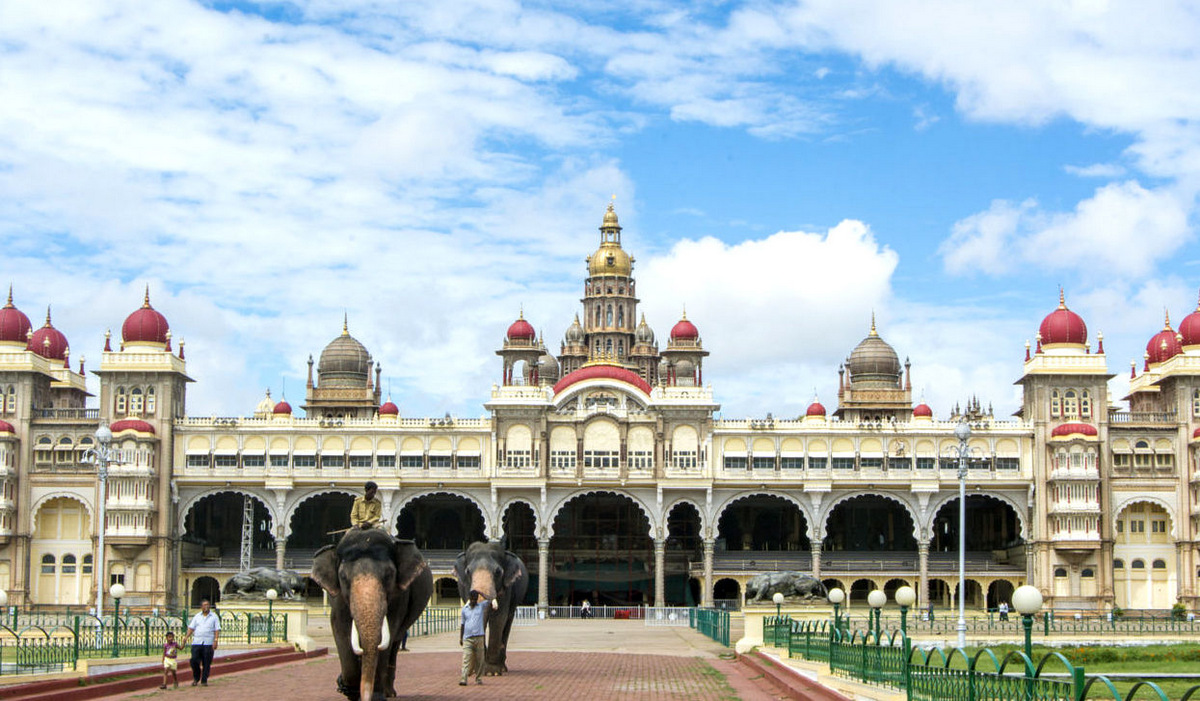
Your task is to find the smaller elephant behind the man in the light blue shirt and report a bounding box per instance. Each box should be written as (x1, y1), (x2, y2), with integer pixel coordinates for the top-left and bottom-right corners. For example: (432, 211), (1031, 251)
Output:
(454, 543), (529, 675)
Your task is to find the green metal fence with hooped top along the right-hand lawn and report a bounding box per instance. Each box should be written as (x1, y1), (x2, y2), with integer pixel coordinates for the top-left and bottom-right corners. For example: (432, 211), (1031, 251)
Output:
(762, 616), (1200, 701)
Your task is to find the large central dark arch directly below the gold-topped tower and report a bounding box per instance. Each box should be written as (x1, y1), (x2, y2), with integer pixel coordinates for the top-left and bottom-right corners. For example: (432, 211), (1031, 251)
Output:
(550, 492), (654, 606)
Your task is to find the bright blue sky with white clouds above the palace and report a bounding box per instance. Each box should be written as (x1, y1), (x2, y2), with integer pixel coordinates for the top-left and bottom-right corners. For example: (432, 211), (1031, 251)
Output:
(0, 0), (1200, 417)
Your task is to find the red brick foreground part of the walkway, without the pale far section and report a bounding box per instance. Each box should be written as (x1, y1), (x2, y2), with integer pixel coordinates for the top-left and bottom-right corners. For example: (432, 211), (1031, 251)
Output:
(105, 651), (781, 701)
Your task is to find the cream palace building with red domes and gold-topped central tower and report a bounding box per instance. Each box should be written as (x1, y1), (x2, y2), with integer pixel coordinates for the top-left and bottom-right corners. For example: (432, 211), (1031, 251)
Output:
(0, 205), (1200, 610)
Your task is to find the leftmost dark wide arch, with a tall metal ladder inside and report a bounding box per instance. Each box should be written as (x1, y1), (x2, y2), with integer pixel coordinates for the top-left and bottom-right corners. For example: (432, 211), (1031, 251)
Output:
(181, 492), (275, 568)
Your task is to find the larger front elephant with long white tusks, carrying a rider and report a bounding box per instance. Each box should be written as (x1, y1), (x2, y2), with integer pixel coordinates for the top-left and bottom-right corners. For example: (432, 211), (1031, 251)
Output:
(312, 528), (433, 701)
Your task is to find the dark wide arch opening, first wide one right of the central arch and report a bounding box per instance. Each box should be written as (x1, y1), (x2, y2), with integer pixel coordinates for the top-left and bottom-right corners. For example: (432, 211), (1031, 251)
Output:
(716, 495), (810, 551)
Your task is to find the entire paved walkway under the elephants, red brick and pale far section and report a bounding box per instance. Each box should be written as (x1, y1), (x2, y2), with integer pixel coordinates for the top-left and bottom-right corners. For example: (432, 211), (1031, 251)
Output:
(105, 621), (782, 701)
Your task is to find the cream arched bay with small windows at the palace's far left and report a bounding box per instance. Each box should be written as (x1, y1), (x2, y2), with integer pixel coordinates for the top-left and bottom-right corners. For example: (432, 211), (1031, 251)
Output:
(30, 497), (96, 605)
